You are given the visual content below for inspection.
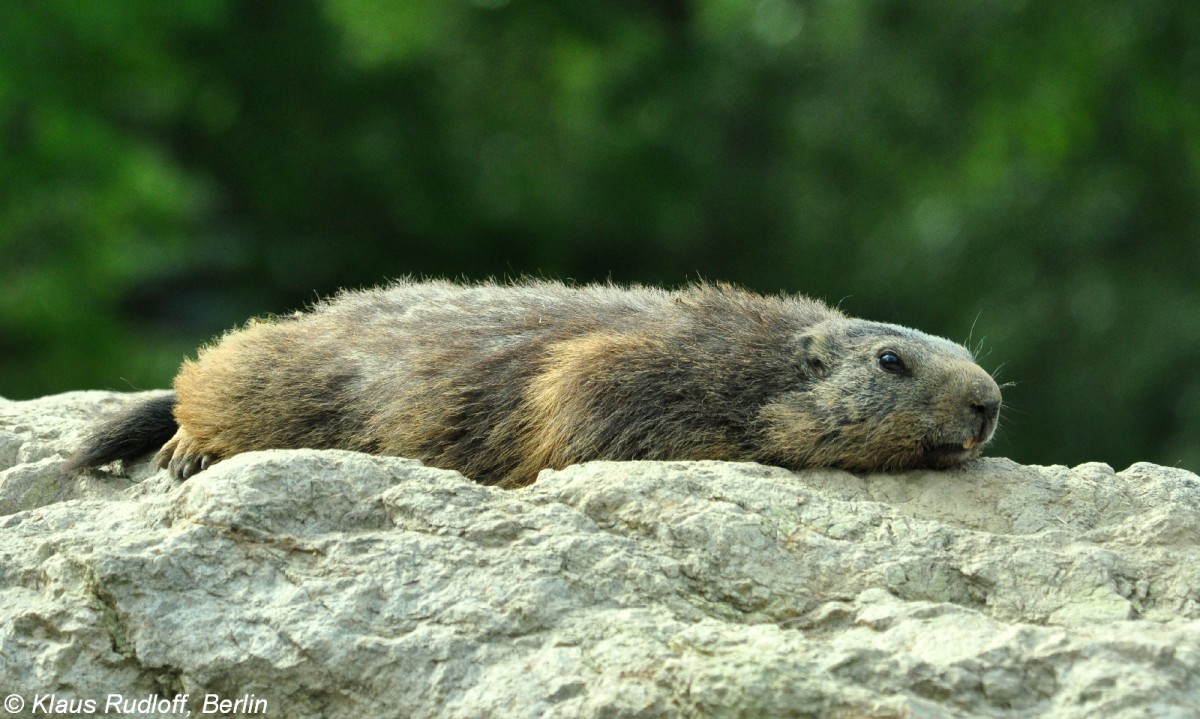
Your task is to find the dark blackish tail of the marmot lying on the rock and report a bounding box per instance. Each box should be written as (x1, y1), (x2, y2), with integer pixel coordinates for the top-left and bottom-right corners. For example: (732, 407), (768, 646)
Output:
(62, 393), (178, 472)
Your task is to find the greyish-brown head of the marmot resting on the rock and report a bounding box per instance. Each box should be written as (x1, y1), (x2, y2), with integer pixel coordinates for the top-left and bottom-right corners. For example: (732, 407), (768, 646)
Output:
(758, 318), (1001, 471)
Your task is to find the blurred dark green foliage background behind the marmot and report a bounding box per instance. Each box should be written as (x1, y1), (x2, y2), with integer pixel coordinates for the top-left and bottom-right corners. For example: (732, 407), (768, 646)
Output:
(0, 0), (1200, 471)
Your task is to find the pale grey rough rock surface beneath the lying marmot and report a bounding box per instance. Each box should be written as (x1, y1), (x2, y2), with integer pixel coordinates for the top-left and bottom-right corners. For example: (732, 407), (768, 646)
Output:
(0, 393), (1200, 719)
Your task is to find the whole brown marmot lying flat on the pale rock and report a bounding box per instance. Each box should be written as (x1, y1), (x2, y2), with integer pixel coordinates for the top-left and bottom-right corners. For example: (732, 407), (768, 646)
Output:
(68, 281), (1001, 487)
